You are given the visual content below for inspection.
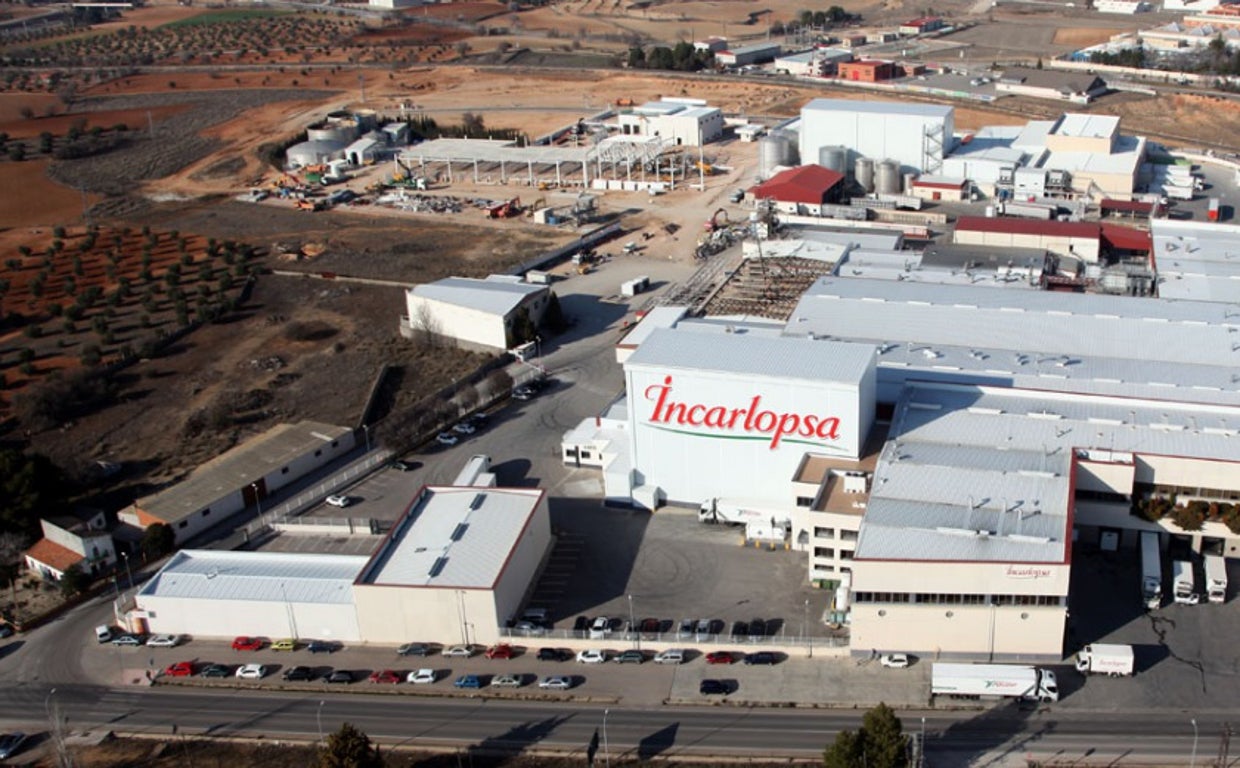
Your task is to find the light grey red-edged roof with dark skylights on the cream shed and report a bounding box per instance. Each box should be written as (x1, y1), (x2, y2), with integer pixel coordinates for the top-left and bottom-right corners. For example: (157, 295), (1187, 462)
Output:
(358, 486), (543, 589)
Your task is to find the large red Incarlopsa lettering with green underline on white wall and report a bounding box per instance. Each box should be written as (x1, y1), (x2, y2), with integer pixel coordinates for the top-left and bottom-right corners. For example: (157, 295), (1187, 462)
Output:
(642, 376), (839, 449)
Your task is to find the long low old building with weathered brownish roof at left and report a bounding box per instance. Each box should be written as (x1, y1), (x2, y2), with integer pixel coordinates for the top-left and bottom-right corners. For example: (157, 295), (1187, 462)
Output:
(118, 421), (356, 543)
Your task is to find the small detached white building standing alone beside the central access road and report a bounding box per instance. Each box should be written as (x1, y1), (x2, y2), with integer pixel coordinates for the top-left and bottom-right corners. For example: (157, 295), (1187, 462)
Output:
(401, 274), (551, 350)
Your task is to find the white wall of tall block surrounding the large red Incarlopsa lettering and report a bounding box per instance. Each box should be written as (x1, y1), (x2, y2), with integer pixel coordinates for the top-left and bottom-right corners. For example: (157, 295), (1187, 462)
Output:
(625, 365), (874, 504)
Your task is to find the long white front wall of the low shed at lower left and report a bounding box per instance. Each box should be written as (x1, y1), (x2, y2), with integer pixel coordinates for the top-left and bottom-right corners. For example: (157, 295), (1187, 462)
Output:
(141, 596), (362, 643)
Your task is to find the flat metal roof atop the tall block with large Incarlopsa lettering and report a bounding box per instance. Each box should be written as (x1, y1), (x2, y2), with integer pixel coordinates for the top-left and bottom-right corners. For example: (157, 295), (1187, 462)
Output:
(625, 329), (874, 385)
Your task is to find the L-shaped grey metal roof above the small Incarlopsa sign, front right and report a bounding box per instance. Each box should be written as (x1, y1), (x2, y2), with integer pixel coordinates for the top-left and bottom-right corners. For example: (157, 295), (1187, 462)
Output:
(856, 383), (1240, 562)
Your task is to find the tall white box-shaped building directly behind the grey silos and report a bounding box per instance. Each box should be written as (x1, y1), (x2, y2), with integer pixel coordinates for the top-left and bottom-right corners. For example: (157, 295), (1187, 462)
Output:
(800, 99), (959, 176)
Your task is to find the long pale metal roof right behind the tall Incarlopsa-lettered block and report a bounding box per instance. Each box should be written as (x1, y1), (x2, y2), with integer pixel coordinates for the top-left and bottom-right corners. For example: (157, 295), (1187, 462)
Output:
(785, 277), (1240, 403)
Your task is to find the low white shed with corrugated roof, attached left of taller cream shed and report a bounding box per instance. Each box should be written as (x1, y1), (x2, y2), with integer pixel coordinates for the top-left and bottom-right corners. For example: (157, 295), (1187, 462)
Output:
(130, 550), (367, 641)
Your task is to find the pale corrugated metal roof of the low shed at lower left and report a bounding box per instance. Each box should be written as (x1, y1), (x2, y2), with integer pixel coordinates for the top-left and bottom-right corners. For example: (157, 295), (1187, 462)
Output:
(138, 550), (367, 605)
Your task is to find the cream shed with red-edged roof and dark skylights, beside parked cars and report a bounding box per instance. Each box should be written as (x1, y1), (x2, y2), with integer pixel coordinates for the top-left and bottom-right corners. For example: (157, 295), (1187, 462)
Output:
(355, 486), (551, 644)
